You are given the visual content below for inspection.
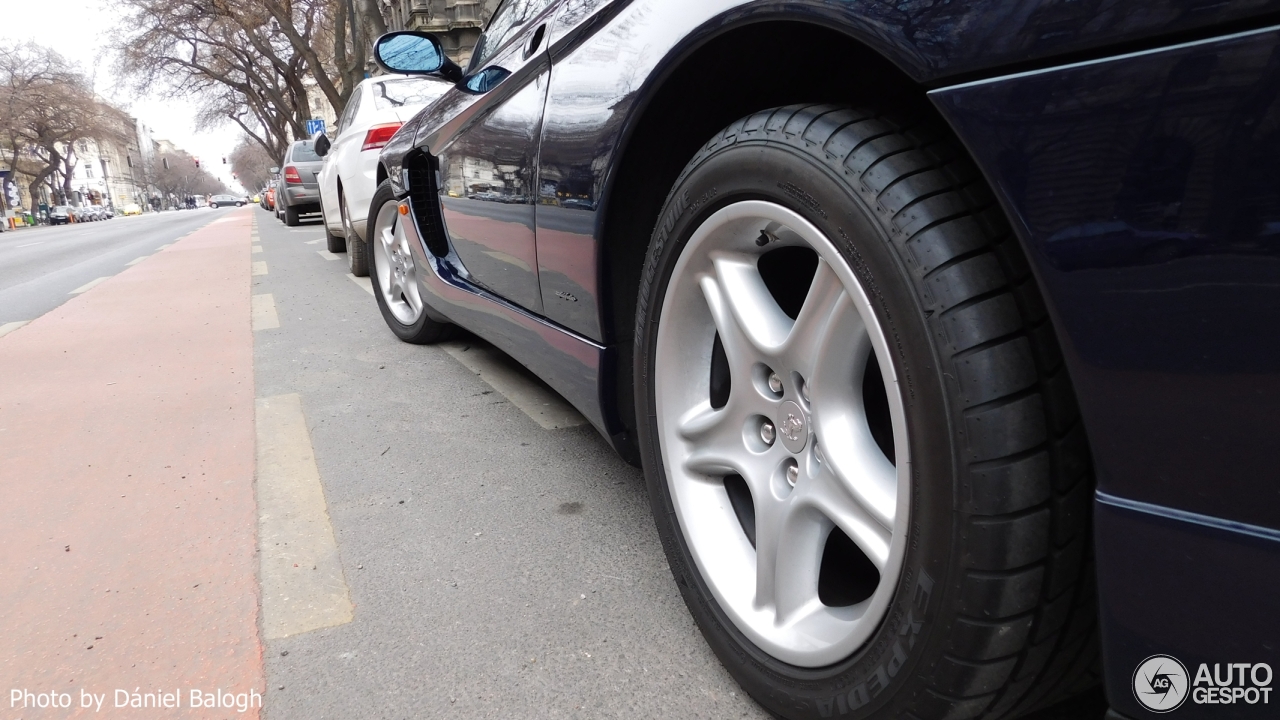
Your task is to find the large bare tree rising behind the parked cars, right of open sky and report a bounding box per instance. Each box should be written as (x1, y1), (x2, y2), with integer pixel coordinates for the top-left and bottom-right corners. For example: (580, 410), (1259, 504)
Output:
(115, 0), (387, 159)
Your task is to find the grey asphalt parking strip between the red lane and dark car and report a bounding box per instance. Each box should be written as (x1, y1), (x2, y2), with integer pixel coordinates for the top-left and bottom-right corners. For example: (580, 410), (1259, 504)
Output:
(252, 210), (767, 720)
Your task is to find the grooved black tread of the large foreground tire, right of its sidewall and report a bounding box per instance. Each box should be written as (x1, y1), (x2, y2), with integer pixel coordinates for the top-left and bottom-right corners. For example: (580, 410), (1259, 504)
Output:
(660, 105), (1100, 720)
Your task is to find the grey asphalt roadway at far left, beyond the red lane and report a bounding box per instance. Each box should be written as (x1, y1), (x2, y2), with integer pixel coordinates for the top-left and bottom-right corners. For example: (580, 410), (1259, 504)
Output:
(0, 208), (229, 325)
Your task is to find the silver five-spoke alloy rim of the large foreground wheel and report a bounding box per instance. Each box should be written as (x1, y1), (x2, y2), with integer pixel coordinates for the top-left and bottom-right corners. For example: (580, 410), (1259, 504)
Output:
(654, 200), (911, 667)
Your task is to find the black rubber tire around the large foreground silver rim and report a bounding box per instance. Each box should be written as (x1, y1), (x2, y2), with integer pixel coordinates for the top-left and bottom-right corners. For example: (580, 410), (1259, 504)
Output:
(635, 105), (1098, 720)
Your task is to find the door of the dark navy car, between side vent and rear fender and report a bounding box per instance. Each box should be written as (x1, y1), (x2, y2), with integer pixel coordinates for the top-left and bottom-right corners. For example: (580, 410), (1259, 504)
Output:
(431, 0), (559, 313)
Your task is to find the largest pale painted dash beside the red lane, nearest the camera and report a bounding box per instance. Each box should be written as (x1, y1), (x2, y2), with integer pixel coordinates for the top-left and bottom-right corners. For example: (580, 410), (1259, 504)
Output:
(255, 393), (355, 641)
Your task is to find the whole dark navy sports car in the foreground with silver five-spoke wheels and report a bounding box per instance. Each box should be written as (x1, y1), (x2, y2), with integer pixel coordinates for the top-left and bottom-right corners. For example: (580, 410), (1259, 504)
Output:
(366, 0), (1280, 720)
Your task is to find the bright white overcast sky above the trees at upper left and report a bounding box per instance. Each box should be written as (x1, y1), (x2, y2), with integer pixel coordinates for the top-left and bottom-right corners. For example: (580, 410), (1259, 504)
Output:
(0, 0), (239, 190)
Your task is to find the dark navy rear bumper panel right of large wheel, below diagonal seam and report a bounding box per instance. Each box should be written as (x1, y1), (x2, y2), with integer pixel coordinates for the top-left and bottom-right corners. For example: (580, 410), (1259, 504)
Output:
(932, 23), (1280, 717)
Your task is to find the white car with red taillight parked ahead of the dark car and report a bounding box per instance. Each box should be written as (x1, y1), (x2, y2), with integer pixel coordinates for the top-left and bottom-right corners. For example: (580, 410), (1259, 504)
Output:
(319, 74), (453, 277)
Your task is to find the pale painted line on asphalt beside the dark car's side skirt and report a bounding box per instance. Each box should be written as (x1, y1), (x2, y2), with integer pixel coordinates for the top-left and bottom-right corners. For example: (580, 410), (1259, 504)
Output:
(436, 341), (586, 430)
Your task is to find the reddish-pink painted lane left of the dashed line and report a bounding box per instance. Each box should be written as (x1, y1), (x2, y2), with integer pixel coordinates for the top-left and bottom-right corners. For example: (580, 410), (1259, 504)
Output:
(0, 209), (265, 717)
